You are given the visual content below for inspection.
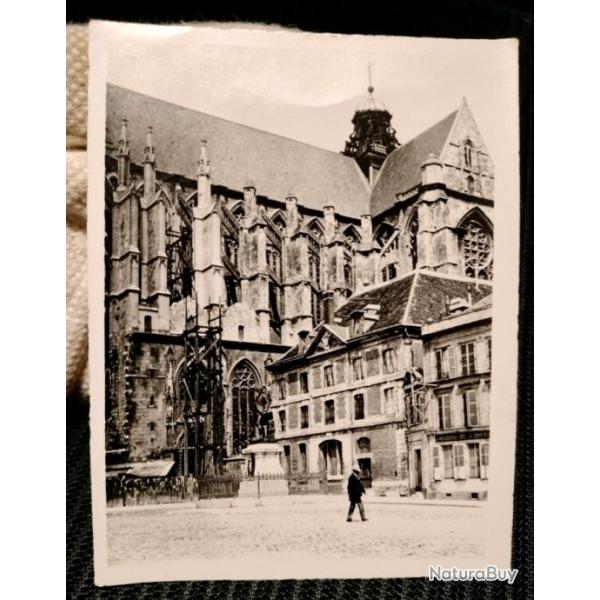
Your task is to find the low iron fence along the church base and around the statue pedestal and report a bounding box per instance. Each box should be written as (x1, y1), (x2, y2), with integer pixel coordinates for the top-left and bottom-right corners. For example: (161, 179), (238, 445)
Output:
(106, 473), (328, 507)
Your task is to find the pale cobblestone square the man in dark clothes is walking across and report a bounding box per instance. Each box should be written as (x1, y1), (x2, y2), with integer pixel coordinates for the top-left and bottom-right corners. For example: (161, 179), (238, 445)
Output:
(108, 496), (485, 578)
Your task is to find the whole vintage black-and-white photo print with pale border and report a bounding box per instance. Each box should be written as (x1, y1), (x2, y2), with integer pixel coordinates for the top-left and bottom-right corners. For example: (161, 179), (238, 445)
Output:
(88, 22), (519, 584)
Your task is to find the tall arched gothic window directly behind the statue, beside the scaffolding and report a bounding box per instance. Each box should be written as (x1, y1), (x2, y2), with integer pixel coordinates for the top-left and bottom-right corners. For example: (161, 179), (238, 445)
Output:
(231, 360), (259, 454)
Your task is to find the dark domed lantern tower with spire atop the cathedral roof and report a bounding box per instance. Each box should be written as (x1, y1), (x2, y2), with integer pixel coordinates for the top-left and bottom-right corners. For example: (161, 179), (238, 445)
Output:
(343, 64), (400, 185)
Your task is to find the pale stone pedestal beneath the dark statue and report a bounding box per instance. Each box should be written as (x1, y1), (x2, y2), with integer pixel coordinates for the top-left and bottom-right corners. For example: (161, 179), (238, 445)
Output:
(238, 443), (288, 497)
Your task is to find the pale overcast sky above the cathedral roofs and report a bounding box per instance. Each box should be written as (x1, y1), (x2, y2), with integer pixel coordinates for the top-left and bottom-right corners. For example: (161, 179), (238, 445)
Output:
(101, 25), (517, 165)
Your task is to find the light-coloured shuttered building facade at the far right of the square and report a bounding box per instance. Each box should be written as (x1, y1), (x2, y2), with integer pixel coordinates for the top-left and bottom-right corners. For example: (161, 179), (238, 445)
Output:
(406, 295), (492, 499)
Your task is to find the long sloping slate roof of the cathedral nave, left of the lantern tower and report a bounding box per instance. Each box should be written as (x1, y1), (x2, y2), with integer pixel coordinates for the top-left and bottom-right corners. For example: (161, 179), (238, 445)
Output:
(106, 84), (370, 217)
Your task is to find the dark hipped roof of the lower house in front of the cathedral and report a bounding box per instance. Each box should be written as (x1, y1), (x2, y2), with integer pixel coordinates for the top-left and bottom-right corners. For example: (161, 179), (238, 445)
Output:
(335, 271), (492, 332)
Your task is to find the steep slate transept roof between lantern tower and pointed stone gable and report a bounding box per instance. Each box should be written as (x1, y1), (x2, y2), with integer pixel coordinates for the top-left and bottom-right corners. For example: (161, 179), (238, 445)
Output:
(371, 110), (458, 216)
